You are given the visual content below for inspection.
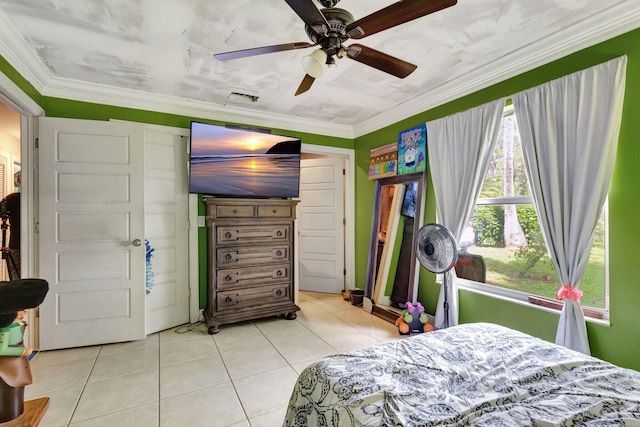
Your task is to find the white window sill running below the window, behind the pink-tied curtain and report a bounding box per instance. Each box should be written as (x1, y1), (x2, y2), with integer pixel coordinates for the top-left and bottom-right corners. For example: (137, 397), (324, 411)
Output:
(458, 278), (610, 326)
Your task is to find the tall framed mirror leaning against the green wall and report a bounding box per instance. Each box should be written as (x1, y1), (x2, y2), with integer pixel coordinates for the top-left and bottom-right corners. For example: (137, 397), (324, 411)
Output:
(365, 172), (426, 322)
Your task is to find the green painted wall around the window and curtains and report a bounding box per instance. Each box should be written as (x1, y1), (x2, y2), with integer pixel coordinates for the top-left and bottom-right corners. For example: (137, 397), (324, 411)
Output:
(355, 30), (640, 370)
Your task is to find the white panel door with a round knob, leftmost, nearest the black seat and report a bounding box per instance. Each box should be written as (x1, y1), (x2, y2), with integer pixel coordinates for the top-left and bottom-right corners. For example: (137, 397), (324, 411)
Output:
(38, 118), (145, 350)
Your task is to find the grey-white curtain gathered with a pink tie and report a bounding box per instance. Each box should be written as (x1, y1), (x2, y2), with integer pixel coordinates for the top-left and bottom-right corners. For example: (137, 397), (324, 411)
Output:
(513, 56), (627, 354)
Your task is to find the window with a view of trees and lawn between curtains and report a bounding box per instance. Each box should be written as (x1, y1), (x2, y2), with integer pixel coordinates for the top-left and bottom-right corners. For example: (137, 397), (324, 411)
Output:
(459, 107), (608, 317)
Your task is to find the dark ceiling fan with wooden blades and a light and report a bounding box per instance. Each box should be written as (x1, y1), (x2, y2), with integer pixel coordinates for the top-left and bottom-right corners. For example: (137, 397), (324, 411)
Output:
(213, 0), (457, 95)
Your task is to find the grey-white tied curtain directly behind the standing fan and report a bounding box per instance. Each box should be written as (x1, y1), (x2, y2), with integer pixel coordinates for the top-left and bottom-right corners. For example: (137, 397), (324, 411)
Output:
(427, 98), (504, 328)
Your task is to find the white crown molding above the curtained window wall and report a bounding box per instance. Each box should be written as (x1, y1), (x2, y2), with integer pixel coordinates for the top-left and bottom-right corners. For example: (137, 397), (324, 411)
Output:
(353, 1), (640, 137)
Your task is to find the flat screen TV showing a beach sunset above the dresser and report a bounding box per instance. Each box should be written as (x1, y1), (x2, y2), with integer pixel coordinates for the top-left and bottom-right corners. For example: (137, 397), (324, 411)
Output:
(189, 122), (301, 198)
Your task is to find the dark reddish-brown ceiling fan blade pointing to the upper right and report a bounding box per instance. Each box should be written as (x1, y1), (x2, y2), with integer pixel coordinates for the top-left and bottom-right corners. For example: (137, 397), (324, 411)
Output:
(346, 0), (457, 39)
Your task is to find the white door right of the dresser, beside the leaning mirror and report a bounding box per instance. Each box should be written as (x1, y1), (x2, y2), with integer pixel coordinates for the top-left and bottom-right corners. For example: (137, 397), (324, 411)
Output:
(298, 157), (345, 293)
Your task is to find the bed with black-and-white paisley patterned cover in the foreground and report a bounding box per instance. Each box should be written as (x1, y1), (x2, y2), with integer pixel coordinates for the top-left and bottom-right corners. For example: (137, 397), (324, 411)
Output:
(284, 323), (640, 427)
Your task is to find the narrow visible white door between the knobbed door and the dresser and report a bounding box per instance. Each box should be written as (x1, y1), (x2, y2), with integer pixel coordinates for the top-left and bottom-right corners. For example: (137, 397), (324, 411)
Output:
(144, 128), (190, 334)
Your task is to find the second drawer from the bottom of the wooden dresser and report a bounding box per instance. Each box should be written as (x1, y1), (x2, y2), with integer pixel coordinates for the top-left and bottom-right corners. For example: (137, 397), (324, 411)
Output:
(216, 263), (291, 291)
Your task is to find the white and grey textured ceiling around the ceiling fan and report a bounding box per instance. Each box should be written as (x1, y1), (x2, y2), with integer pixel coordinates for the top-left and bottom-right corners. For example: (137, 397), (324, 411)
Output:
(0, 0), (640, 134)
